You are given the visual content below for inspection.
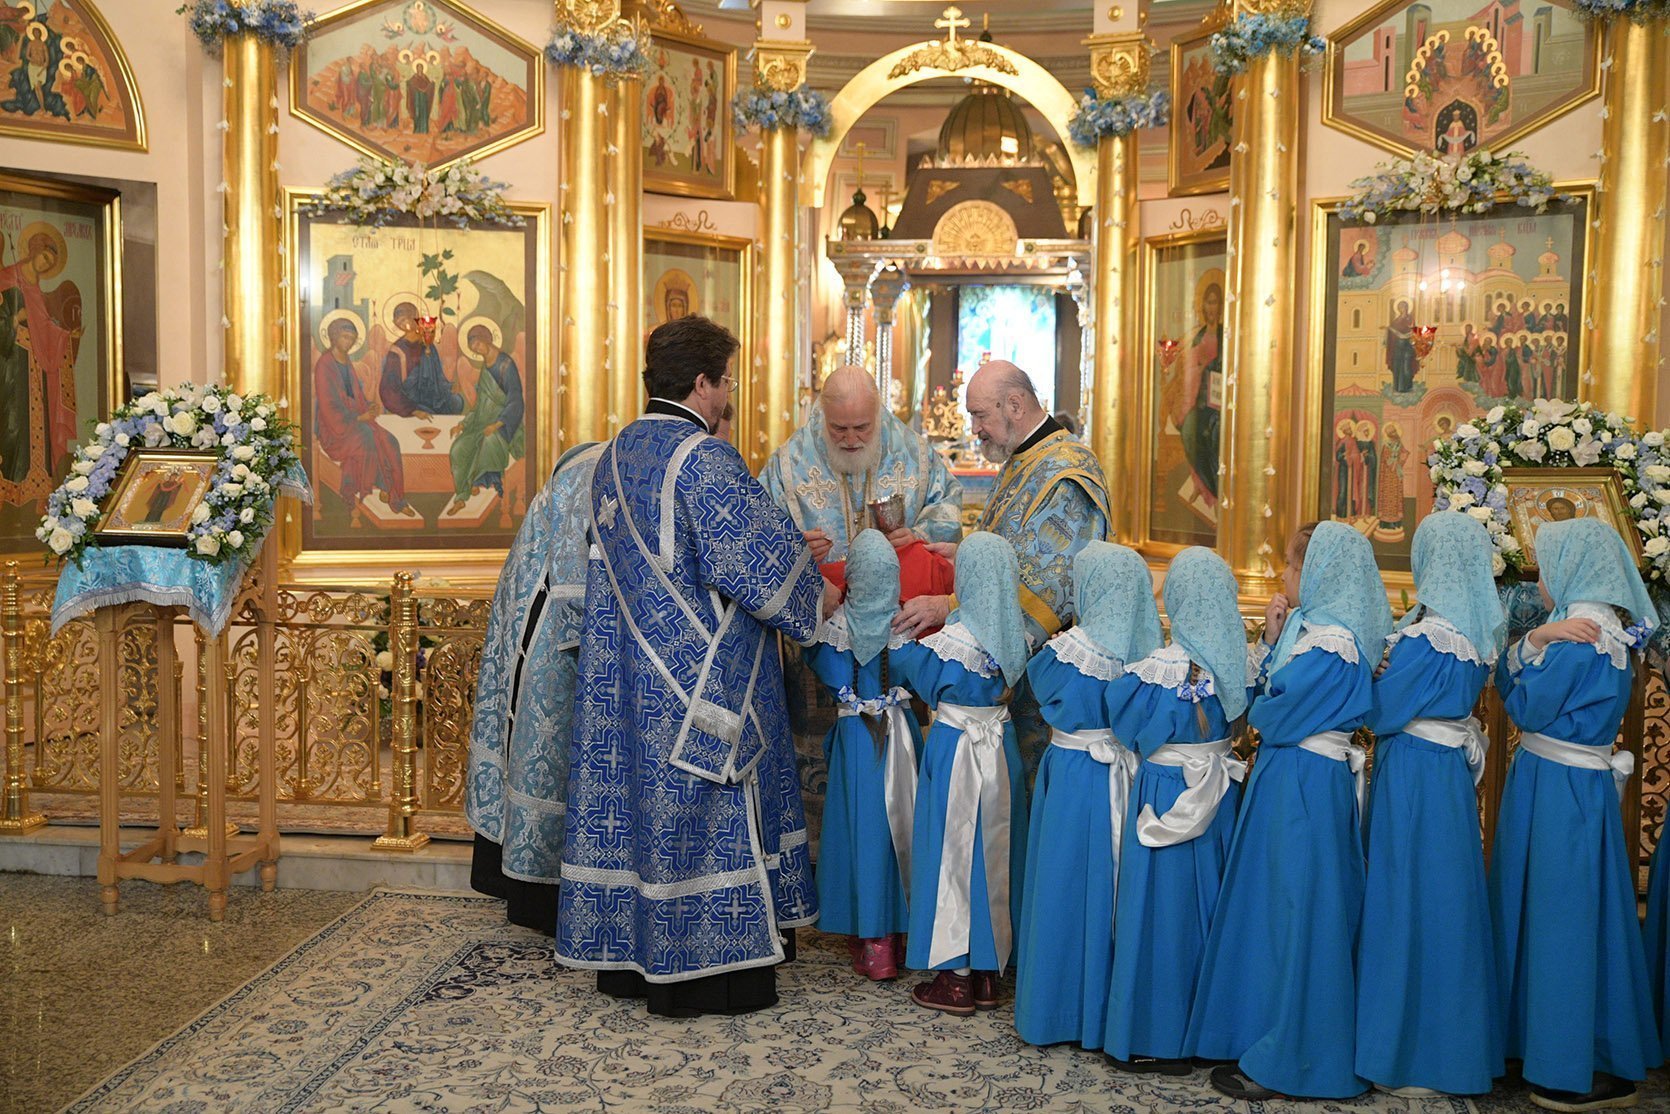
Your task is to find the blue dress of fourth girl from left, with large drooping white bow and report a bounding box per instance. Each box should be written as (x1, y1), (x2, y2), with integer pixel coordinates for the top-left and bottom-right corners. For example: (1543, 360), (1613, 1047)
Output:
(1102, 654), (1241, 1061)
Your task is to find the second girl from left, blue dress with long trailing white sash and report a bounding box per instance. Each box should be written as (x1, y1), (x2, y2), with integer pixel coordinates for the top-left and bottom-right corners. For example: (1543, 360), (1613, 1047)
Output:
(890, 531), (1029, 1015)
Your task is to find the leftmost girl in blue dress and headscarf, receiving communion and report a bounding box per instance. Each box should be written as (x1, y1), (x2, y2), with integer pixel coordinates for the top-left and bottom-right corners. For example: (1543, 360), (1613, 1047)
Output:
(805, 529), (922, 980)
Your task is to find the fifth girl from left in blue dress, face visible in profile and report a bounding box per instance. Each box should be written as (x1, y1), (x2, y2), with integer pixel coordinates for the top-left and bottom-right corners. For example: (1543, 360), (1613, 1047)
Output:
(1187, 523), (1391, 1099)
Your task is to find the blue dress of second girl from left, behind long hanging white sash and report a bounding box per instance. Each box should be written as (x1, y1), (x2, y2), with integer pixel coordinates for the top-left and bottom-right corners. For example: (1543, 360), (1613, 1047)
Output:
(890, 626), (1027, 970)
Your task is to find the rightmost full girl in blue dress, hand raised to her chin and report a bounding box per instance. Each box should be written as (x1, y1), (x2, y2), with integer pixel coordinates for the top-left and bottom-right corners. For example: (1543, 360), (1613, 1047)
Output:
(1490, 518), (1662, 1111)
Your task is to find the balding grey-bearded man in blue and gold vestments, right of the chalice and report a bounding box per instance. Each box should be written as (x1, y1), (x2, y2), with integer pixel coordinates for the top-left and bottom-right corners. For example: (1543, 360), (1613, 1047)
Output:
(893, 359), (1109, 772)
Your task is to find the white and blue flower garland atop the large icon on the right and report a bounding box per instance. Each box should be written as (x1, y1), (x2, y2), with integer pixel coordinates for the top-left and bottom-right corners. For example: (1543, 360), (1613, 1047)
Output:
(1339, 147), (1568, 224)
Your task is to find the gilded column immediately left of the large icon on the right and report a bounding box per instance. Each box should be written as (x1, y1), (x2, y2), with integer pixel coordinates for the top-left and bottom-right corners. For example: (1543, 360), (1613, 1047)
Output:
(1217, 0), (1309, 595)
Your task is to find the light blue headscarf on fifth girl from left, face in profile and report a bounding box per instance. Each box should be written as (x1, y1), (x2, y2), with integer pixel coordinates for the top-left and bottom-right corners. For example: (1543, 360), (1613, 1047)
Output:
(1269, 523), (1391, 673)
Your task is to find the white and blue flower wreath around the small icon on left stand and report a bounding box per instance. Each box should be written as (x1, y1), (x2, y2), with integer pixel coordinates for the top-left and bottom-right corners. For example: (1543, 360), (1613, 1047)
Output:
(35, 384), (304, 565)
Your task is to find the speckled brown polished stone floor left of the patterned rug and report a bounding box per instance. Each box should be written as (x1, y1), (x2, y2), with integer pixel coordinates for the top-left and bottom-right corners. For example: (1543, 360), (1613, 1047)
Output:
(0, 873), (366, 1114)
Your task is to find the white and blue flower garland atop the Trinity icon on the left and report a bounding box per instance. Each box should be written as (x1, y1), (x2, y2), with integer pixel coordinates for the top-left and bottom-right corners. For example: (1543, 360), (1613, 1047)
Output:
(306, 157), (524, 229)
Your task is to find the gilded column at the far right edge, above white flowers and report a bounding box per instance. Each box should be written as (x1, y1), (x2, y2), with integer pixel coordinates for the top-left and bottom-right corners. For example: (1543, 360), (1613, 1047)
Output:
(1581, 17), (1670, 426)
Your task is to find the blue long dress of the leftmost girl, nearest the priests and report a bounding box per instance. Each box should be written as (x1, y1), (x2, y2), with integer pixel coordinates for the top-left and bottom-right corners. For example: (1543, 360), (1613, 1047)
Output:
(803, 611), (922, 940)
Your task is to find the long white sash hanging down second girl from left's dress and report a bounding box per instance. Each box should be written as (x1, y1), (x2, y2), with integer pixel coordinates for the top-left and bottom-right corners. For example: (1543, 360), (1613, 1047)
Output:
(929, 703), (1014, 970)
